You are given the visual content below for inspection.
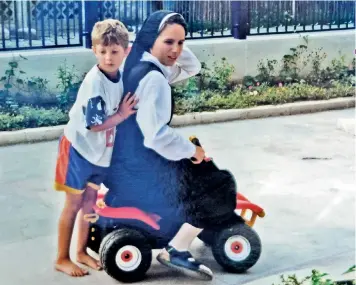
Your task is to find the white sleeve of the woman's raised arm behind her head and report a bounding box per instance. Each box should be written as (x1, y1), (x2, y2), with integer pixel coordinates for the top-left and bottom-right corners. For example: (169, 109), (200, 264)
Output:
(168, 44), (201, 84)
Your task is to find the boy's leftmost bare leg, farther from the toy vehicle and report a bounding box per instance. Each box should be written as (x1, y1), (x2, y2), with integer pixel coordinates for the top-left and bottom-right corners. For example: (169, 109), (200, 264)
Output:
(55, 193), (88, 277)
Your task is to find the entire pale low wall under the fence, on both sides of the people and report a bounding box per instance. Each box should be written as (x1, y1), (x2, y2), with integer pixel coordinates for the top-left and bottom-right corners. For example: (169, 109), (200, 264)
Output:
(0, 30), (355, 90)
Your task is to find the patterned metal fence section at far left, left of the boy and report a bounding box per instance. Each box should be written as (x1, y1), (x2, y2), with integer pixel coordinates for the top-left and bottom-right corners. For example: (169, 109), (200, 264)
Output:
(0, 1), (83, 51)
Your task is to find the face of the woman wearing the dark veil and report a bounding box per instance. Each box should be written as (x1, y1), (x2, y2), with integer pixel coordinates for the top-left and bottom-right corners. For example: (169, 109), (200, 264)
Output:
(151, 24), (185, 66)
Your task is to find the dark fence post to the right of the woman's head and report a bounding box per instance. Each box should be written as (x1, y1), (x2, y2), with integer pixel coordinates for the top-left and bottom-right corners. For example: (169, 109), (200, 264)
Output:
(231, 1), (250, 40)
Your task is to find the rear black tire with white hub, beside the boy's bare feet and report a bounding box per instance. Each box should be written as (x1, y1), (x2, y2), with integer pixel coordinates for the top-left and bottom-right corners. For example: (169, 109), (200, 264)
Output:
(99, 229), (152, 283)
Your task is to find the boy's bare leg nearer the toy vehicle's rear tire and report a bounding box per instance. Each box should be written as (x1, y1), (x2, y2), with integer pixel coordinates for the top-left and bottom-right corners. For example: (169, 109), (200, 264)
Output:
(77, 185), (102, 270)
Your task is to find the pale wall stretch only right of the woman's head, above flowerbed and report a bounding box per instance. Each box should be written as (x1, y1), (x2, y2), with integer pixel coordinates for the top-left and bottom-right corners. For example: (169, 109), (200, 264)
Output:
(189, 30), (355, 78)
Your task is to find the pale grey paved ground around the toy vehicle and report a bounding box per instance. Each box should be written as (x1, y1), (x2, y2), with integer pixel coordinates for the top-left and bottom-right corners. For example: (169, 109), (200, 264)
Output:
(0, 109), (356, 285)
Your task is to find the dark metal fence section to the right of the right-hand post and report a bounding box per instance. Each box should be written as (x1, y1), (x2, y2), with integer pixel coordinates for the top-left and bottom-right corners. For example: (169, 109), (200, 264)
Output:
(248, 0), (355, 35)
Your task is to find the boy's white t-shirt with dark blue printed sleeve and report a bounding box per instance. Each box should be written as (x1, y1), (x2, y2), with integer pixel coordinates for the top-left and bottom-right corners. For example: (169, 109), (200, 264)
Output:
(64, 65), (123, 167)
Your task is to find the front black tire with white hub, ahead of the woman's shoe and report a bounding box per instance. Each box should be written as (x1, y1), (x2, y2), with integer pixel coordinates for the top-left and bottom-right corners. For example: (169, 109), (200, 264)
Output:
(212, 223), (262, 273)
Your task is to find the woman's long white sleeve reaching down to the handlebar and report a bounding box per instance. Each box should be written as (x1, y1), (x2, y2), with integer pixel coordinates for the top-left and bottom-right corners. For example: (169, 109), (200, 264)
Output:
(135, 71), (196, 161)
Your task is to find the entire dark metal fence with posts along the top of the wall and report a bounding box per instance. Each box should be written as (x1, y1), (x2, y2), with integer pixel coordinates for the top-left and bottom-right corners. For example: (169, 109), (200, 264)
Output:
(0, 0), (355, 51)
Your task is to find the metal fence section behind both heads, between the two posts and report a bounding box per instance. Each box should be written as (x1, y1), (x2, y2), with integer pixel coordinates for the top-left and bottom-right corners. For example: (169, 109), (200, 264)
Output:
(85, 0), (231, 45)
